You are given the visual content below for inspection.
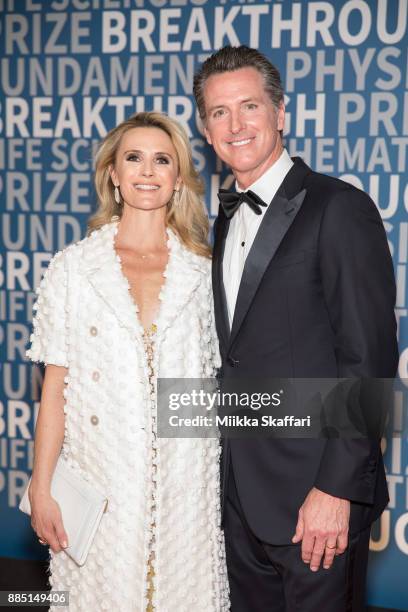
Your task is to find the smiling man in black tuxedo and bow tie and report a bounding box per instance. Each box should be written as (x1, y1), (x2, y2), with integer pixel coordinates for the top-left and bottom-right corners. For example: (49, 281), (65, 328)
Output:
(194, 46), (398, 612)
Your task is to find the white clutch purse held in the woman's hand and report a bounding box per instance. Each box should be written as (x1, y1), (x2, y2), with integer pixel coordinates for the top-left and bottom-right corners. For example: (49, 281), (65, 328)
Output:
(19, 456), (108, 565)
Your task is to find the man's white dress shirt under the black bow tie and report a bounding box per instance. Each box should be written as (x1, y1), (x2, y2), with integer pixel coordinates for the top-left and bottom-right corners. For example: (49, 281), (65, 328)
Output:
(222, 149), (293, 328)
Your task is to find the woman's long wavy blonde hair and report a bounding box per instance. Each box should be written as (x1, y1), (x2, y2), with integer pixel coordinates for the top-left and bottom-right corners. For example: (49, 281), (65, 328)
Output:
(88, 112), (211, 257)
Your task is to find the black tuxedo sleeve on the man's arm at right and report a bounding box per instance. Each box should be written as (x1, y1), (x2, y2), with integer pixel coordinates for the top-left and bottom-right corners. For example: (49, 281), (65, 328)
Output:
(315, 186), (398, 504)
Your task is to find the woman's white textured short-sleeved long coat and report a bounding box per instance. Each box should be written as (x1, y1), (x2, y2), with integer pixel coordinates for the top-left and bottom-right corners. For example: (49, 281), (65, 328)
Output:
(27, 221), (229, 612)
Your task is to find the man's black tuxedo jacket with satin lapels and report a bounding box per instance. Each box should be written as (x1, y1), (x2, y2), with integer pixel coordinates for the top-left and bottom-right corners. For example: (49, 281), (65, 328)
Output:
(213, 158), (398, 544)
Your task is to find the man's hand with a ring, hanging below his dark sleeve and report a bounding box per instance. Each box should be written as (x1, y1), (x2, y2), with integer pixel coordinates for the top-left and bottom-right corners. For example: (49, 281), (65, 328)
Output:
(292, 487), (350, 572)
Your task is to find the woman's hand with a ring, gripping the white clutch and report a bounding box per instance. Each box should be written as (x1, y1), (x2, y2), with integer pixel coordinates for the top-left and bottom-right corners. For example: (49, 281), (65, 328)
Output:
(28, 486), (68, 553)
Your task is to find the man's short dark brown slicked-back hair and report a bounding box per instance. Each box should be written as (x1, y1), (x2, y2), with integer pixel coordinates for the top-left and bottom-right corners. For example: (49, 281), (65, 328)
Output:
(193, 45), (283, 121)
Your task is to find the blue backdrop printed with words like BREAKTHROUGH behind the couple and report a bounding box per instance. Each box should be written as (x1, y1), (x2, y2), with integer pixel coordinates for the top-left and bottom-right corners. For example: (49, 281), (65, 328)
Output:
(0, 0), (408, 609)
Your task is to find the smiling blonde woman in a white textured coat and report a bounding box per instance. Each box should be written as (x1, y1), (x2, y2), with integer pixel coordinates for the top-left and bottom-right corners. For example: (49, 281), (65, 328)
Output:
(28, 112), (229, 612)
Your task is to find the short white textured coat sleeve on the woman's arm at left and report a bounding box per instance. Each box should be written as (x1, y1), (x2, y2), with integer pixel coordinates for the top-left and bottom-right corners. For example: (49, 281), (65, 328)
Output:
(26, 252), (68, 367)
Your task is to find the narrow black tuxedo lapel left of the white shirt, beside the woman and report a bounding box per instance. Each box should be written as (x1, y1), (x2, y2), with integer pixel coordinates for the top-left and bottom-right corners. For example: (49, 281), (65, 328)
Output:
(212, 213), (230, 346)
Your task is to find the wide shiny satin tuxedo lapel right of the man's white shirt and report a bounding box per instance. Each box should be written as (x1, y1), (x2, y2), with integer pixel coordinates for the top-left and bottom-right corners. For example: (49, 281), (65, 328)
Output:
(230, 184), (306, 344)
